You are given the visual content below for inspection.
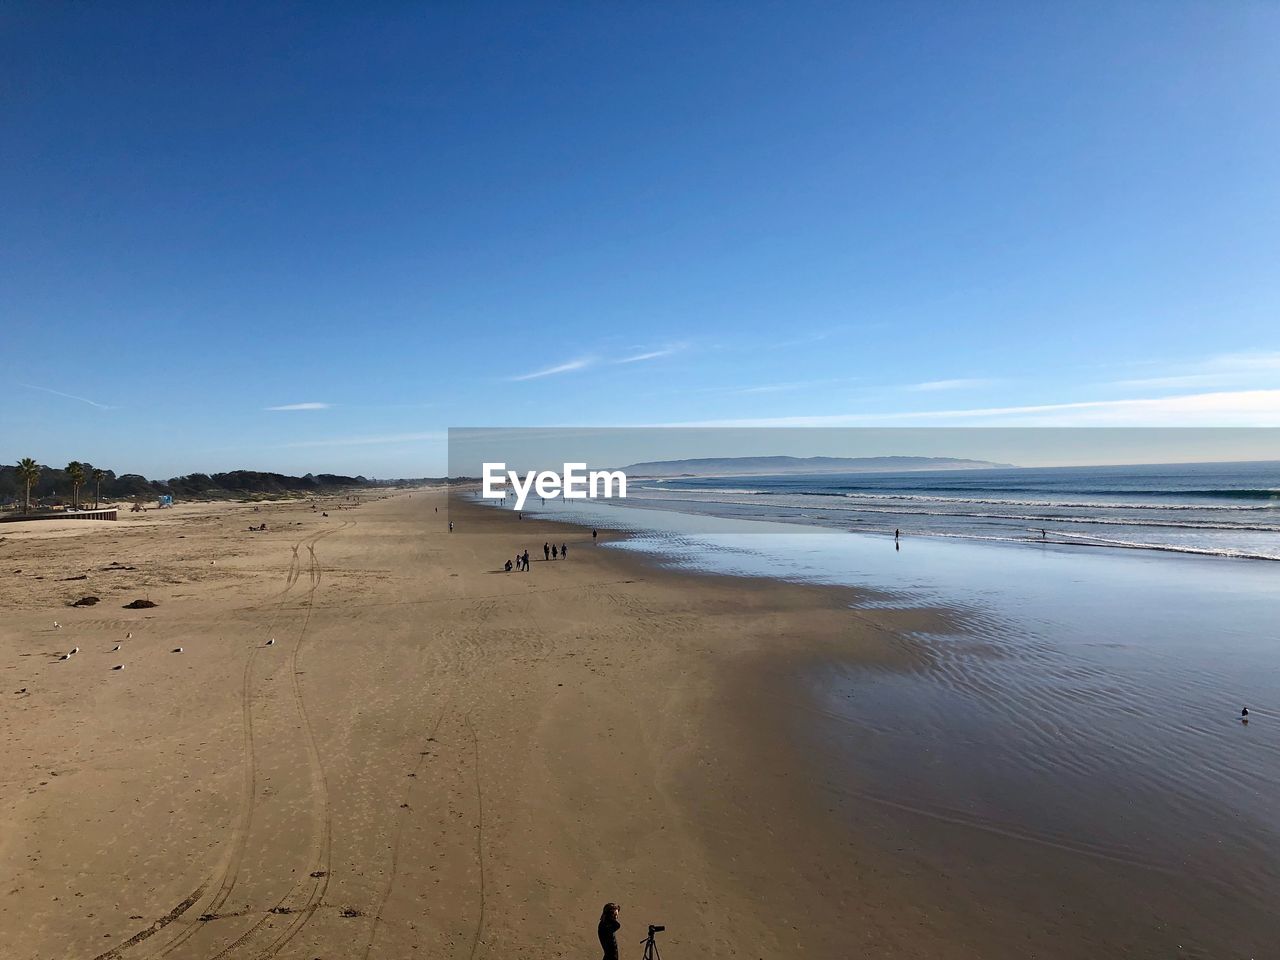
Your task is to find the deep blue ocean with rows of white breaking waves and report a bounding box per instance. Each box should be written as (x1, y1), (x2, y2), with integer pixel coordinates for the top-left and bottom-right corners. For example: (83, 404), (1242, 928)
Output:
(627, 462), (1280, 559)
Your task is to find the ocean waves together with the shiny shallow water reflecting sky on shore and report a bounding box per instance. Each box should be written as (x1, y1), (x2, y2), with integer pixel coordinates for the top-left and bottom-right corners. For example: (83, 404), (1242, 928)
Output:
(476, 463), (1280, 957)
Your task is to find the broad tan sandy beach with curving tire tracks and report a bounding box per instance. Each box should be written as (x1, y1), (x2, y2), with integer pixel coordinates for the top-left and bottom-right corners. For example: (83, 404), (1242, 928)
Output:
(0, 492), (1256, 960)
